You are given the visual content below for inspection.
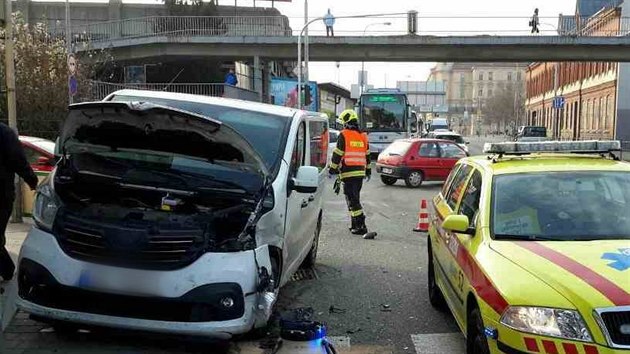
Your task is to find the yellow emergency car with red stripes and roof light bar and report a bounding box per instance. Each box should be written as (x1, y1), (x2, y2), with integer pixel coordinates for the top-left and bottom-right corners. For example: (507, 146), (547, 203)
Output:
(427, 141), (630, 354)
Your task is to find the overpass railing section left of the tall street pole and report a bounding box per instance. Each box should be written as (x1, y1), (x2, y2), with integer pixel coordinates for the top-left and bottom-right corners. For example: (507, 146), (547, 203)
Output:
(71, 16), (292, 41)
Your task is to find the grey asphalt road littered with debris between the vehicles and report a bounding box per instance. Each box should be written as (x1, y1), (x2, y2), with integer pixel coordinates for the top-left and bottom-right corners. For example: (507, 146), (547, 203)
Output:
(0, 134), (499, 354)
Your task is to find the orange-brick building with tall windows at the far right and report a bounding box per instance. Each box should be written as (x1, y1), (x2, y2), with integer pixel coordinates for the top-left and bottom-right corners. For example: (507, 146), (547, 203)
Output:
(526, 0), (622, 140)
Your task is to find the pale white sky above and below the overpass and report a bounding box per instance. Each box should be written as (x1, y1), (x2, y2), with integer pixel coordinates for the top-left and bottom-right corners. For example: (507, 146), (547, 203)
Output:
(219, 0), (576, 89)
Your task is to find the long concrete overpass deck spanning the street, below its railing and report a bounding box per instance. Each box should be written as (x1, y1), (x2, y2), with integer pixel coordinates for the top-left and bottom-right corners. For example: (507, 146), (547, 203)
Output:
(77, 35), (630, 62)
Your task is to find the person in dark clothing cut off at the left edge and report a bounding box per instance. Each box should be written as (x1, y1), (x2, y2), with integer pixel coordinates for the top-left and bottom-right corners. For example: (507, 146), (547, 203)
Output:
(0, 123), (38, 281)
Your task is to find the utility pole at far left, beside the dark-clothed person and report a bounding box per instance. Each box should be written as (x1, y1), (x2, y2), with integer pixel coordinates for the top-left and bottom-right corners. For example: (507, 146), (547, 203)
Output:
(4, 0), (22, 223)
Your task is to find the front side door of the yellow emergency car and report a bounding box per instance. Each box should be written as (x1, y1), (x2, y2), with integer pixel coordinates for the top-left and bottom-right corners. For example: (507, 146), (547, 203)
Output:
(436, 165), (473, 323)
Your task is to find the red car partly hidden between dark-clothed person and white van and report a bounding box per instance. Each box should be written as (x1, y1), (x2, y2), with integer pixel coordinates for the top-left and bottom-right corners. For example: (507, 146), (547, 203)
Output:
(20, 135), (55, 214)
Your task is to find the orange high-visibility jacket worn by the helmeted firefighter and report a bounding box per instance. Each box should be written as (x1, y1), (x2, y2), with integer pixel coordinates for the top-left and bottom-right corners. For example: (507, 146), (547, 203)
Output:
(330, 129), (371, 179)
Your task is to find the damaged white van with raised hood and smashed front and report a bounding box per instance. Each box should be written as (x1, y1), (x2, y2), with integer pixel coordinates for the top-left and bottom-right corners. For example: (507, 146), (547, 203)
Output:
(17, 90), (328, 339)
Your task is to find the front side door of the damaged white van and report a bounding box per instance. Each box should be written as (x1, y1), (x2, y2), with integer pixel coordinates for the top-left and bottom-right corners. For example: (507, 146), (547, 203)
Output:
(284, 119), (311, 276)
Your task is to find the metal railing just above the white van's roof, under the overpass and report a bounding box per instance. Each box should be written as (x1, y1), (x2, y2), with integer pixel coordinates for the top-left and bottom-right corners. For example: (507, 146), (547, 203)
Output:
(91, 81), (260, 101)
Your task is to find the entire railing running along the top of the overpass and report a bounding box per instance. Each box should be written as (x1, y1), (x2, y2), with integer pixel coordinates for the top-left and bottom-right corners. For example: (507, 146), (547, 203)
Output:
(59, 15), (630, 42)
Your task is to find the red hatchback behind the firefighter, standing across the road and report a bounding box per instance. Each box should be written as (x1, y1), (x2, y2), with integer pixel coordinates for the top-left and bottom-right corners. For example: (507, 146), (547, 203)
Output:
(376, 139), (468, 188)
